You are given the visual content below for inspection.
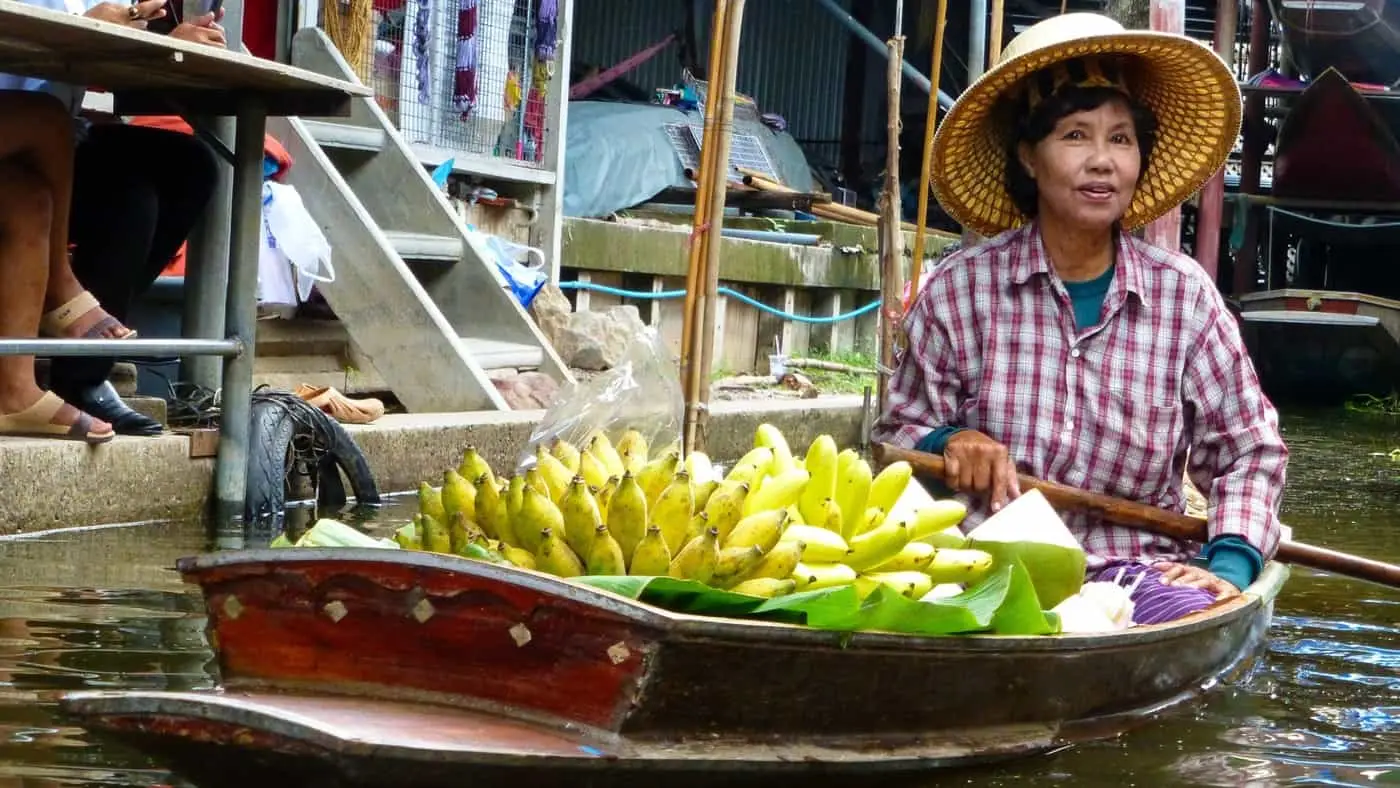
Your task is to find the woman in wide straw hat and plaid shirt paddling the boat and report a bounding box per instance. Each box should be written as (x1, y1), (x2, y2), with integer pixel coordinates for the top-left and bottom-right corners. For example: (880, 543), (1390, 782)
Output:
(875, 14), (1288, 623)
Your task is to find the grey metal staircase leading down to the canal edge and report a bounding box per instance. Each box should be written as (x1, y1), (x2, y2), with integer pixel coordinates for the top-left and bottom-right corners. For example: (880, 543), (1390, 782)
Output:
(267, 28), (571, 411)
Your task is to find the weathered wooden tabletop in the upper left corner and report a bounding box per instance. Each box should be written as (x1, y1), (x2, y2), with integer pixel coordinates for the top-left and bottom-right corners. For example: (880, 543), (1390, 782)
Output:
(0, 0), (370, 115)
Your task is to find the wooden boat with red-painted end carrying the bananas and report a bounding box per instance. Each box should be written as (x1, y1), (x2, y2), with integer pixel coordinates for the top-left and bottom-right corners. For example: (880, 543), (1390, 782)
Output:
(62, 549), (1288, 788)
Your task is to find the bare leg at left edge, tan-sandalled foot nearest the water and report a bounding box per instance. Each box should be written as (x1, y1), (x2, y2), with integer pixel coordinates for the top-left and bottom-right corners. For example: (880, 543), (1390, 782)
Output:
(0, 92), (112, 442)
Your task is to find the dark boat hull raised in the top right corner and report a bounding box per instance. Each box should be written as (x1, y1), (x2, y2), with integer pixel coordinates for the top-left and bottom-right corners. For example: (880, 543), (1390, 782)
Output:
(1270, 0), (1400, 85)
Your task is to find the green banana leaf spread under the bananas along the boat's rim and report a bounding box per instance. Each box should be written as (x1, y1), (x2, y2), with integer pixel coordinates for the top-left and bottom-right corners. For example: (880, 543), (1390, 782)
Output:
(573, 560), (1060, 635)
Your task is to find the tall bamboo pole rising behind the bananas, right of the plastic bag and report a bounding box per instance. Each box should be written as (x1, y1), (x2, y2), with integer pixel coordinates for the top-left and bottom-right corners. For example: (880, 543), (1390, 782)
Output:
(686, 0), (743, 451)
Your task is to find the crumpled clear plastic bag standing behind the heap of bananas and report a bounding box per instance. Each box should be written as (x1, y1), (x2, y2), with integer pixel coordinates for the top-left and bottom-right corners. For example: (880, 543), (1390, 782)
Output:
(517, 328), (685, 473)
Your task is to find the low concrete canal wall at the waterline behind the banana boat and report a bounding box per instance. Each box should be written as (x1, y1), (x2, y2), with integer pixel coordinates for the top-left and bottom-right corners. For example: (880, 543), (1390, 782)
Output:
(0, 396), (861, 535)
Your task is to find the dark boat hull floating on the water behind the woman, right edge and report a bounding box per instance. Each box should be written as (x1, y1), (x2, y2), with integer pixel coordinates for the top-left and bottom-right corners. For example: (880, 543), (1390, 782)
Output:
(1240, 290), (1400, 404)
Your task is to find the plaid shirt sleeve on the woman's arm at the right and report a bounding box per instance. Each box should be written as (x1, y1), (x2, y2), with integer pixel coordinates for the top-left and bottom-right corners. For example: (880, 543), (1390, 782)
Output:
(1184, 287), (1288, 560)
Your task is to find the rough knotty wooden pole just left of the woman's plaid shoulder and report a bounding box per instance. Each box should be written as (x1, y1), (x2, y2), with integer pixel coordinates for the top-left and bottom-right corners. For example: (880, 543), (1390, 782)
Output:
(876, 27), (907, 402)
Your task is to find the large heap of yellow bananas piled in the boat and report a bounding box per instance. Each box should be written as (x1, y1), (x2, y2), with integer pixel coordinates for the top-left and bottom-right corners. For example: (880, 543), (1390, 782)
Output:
(395, 424), (993, 599)
